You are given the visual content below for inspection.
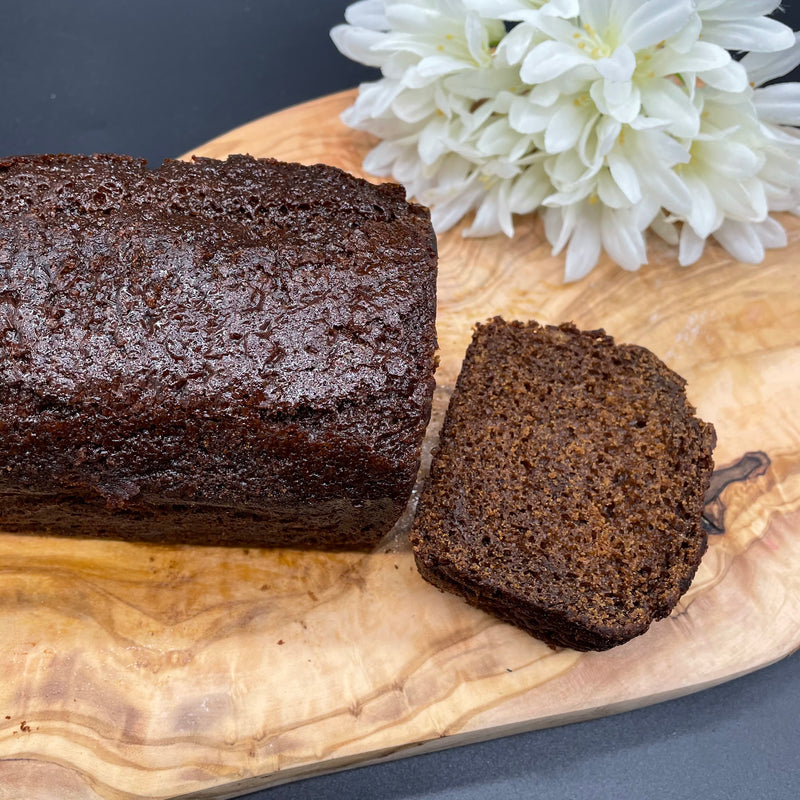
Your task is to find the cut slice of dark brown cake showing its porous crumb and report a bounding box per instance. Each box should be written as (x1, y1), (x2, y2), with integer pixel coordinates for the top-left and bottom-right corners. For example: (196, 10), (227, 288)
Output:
(411, 319), (715, 650)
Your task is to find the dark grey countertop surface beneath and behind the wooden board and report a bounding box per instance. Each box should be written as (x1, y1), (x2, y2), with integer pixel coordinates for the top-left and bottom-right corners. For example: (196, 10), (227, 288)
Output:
(0, 0), (800, 800)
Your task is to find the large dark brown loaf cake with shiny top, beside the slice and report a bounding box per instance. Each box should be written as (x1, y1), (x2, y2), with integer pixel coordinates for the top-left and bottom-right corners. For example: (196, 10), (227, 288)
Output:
(0, 156), (436, 547)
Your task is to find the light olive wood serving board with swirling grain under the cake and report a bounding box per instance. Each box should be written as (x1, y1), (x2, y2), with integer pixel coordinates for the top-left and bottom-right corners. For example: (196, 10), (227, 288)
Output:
(0, 92), (800, 800)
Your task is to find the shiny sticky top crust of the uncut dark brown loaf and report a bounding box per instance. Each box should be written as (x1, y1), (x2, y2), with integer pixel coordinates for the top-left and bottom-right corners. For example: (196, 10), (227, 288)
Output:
(0, 156), (436, 422)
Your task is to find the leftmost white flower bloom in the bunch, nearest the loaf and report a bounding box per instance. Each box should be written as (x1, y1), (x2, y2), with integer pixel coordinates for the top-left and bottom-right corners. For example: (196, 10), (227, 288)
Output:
(331, 0), (532, 236)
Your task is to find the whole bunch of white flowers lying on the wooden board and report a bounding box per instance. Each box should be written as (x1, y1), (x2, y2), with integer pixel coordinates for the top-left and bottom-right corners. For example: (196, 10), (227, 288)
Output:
(332, 0), (800, 280)
